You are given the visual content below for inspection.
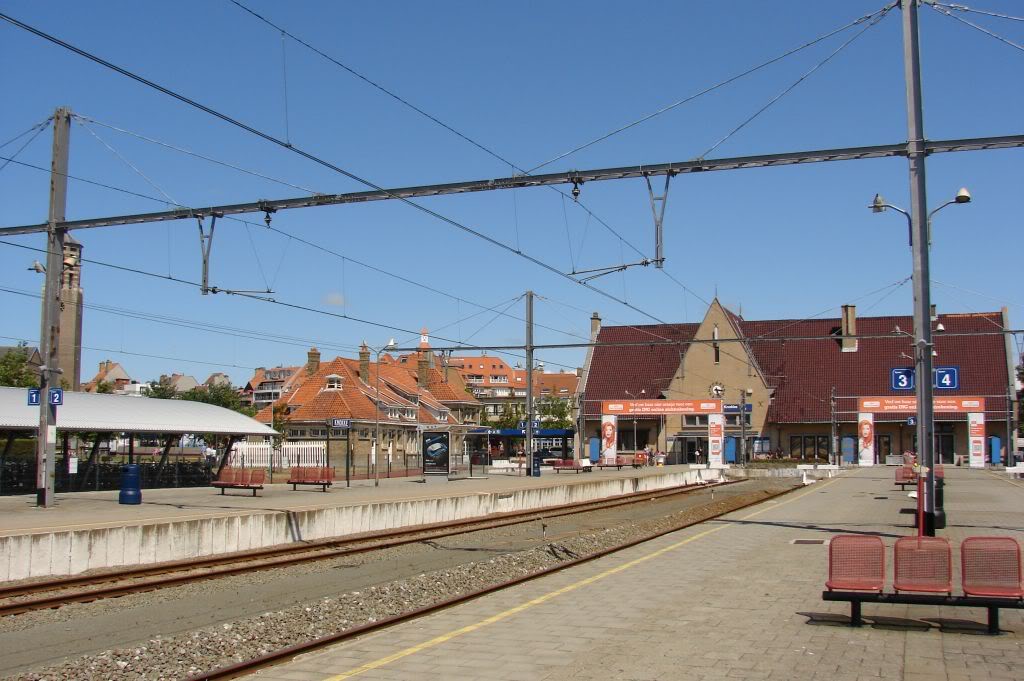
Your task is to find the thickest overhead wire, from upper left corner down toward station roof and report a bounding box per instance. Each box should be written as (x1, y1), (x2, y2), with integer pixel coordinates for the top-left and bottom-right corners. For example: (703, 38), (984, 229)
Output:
(0, 12), (663, 323)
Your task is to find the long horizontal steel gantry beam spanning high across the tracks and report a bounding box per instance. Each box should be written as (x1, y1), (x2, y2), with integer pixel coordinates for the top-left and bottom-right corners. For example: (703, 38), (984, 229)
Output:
(0, 134), (1024, 237)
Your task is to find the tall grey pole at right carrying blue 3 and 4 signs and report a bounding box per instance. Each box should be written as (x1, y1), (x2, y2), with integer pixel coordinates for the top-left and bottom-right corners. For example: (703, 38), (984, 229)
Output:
(900, 0), (945, 537)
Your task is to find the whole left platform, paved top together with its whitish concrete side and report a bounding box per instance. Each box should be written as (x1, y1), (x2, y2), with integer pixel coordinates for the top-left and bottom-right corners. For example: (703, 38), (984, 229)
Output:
(0, 466), (721, 582)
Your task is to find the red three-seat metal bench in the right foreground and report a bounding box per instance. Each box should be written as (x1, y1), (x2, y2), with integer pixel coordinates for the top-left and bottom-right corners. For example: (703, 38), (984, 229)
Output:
(821, 535), (1024, 634)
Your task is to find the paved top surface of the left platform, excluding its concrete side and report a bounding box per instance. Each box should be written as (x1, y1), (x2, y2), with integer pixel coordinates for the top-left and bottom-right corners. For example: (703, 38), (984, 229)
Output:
(0, 466), (689, 537)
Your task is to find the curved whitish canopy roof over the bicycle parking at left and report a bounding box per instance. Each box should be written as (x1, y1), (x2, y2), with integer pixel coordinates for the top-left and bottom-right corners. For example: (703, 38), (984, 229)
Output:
(0, 387), (276, 435)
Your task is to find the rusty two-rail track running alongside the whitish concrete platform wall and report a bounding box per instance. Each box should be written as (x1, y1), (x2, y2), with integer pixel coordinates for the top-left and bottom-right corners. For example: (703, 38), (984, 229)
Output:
(0, 482), (735, 616)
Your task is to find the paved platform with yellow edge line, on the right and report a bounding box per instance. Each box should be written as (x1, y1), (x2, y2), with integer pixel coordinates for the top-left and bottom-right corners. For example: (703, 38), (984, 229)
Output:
(257, 467), (1024, 681)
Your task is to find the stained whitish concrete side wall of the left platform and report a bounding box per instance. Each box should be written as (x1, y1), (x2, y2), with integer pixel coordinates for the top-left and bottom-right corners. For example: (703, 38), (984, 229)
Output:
(0, 470), (720, 582)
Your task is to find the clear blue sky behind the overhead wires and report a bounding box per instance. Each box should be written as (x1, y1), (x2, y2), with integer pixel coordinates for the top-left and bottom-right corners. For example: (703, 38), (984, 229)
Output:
(0, 0), (1024, 383)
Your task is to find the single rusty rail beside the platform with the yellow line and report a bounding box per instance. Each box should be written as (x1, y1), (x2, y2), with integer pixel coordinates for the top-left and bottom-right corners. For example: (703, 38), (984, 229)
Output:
(185, 486), (803, 681)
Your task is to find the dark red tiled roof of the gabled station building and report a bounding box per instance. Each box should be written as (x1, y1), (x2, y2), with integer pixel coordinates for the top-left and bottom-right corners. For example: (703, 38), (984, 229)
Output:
(585, 312), (1007, 423)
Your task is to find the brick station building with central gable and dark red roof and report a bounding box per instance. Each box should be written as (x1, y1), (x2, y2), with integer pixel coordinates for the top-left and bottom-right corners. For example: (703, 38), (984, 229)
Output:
(577, 299), (1017, 463)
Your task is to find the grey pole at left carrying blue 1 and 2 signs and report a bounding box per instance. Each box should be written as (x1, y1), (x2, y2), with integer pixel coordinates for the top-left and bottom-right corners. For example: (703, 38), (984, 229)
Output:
(36, 107), (71, 508)
